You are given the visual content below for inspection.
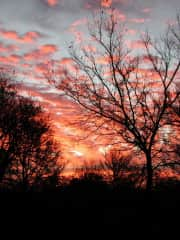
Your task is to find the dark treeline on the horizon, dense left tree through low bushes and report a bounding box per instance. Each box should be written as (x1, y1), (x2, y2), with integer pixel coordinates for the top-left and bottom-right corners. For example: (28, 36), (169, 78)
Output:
(0, 72), (179, 195)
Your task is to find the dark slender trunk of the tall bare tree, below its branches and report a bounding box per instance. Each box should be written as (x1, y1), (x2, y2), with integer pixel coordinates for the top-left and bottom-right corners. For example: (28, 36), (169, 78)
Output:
(146, 151), (153, 193)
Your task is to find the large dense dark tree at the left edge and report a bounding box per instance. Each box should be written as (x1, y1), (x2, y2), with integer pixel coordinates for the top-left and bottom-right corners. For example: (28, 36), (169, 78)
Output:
(0, 72), (65, 190)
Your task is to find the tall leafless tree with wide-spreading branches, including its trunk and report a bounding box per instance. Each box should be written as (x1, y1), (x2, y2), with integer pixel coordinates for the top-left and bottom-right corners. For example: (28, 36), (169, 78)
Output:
(51, 10), (180, 191)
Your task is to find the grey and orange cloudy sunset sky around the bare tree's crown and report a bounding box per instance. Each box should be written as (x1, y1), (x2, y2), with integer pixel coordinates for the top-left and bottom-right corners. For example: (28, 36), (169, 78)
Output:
(0, 0), (180, 169)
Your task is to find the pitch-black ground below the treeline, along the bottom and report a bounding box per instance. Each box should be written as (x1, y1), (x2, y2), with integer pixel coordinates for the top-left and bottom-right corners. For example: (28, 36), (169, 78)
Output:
(0, 184), (180, 236)
